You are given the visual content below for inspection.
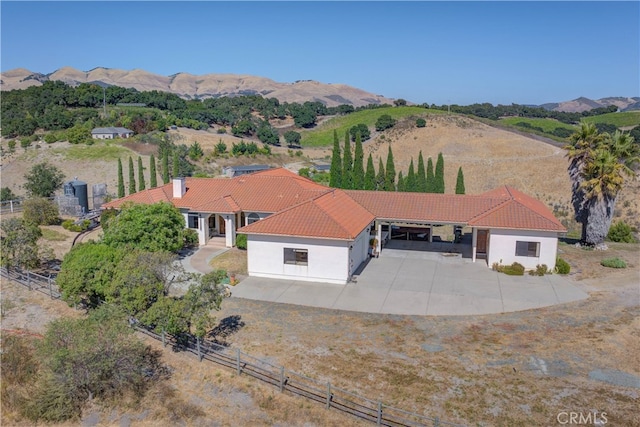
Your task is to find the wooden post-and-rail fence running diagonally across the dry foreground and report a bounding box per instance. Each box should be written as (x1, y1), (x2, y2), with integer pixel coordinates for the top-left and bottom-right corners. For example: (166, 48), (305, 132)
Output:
(0, 268), (460, 427)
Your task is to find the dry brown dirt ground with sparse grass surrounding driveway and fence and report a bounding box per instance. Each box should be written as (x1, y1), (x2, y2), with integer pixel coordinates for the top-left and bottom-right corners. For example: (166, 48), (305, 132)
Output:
(2, 239), (640, 426)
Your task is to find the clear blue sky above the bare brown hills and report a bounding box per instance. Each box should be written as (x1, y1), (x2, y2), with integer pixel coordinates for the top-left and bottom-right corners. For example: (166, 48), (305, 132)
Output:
(0, 0), (640, 105)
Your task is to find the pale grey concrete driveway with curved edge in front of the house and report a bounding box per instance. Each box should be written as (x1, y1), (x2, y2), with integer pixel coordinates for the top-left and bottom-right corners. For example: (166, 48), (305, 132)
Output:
(232, 249), (588, 315)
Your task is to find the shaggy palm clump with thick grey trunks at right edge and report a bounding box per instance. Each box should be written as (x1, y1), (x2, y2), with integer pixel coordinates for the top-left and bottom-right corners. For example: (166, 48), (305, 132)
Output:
(566, 123), (640, 245)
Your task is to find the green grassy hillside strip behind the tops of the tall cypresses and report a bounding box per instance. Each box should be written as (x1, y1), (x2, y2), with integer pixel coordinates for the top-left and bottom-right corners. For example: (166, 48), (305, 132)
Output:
(301, 107), (446, 147)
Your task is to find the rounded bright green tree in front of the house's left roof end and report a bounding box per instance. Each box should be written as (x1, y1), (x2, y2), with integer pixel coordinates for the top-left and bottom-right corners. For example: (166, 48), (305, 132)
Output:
(102, 202), (185, 252)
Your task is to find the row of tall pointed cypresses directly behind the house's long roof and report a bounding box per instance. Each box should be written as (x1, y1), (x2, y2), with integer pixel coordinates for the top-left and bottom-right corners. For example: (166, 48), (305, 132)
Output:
(329, 130), (465, 194)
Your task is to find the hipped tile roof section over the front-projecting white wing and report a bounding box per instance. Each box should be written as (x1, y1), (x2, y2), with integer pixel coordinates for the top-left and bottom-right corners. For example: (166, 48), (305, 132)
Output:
(238, 190), (375, 240)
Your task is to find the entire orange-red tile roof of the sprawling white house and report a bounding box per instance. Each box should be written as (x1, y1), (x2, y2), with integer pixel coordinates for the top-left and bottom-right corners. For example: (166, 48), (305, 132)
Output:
(104, 168), (566, 238)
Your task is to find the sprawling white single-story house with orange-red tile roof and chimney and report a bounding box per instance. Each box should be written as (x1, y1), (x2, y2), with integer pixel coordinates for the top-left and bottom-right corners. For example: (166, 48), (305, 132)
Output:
(104, 168), (566, 284)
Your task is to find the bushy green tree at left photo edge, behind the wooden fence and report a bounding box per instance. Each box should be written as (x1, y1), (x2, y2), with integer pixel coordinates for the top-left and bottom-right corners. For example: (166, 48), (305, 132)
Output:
(0, 218), (42, 269)
